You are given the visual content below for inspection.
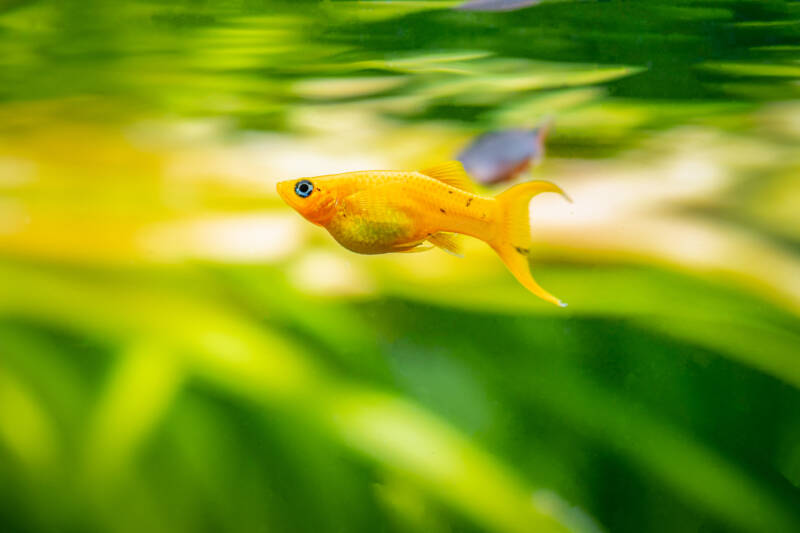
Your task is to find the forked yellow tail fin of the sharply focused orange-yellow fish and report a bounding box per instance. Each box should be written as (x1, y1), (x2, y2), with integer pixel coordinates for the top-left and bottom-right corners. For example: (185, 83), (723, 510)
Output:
(489, 181), (569, 307)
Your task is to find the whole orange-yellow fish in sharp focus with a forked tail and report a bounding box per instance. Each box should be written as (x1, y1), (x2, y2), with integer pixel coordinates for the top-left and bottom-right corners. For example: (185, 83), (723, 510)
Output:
(277, 161), (568, 307)
